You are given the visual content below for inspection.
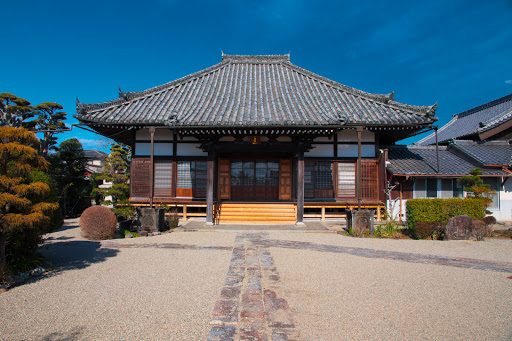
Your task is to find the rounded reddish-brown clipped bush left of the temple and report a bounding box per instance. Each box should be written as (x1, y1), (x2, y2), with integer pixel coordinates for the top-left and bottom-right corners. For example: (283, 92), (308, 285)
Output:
(80, 206), (117, 240)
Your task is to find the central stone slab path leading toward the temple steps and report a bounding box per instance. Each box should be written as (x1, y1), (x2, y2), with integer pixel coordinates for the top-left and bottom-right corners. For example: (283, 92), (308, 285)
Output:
(208, 233), (299, 341)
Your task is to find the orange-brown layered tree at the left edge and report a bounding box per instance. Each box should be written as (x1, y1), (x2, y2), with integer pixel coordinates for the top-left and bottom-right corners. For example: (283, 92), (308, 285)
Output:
(0, 127), (58, 273)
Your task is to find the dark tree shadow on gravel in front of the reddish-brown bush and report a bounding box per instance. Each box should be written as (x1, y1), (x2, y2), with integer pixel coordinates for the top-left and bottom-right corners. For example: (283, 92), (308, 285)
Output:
(40, 241), (119, 273)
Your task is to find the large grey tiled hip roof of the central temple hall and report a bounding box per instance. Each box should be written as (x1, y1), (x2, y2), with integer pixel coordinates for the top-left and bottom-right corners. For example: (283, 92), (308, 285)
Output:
(75, 55), (437, 127)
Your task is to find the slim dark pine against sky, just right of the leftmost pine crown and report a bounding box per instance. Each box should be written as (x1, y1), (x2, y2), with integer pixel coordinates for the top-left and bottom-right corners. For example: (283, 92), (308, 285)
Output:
(31, 102), (67, 157)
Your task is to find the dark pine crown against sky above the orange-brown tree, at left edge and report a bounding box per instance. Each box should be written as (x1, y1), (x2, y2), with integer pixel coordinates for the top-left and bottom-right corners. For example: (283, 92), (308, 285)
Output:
(0, 92), (34, 128)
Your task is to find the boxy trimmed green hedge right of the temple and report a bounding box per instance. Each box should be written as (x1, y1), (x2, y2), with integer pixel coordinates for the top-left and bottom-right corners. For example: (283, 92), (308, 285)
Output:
(406, 197), (486, 229)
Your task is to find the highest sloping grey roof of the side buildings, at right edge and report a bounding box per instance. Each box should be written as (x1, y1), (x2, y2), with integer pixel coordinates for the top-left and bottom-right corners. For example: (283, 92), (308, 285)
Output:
(416, 94), (512, 145)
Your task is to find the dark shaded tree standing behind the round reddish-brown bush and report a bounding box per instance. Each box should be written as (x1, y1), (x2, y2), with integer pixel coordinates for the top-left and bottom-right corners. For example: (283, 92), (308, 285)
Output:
(54, 138), (90, 217)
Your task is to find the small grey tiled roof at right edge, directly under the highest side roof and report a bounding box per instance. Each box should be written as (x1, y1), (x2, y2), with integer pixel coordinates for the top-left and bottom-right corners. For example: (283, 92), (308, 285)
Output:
(449, 140), (512, 167)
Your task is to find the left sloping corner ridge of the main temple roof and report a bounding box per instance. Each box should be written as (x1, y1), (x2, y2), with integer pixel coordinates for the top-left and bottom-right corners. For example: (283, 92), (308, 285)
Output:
(77, 61), (228, 113)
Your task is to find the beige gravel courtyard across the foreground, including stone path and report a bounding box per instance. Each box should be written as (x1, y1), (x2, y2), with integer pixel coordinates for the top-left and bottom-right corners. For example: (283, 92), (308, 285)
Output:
(0, 221), (512, 341)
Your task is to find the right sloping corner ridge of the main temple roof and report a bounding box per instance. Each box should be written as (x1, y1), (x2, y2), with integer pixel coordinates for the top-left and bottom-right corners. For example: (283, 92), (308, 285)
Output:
(283, 61), (437, 117)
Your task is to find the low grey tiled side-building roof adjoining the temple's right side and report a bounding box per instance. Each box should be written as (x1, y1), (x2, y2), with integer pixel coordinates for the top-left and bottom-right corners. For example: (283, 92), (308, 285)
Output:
(387, 146), (510, 176)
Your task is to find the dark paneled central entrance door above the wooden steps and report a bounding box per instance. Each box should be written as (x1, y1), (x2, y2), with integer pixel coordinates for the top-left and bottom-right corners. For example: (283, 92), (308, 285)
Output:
(231, 160), (279, 201)
